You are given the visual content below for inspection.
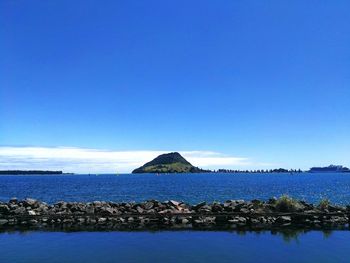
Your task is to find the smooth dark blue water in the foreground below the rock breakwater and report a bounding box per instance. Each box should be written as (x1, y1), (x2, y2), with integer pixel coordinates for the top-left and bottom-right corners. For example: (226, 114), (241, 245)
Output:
(0, 231), (350, 263)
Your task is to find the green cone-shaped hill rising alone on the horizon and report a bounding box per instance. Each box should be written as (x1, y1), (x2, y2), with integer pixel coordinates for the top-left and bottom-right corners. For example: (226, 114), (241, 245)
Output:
(132, 152), (210, 173)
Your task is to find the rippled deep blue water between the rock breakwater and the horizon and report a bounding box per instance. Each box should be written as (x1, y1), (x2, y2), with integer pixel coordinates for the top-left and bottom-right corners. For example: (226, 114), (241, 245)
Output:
(0, 173), (350, 204)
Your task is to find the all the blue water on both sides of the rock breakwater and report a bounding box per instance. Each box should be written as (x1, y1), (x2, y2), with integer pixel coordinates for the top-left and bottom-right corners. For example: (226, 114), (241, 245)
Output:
(0, 174), (350, 263)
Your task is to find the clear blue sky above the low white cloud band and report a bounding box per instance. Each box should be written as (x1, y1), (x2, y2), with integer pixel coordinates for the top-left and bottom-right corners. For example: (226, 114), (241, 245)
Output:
(0, 0), (350, 171)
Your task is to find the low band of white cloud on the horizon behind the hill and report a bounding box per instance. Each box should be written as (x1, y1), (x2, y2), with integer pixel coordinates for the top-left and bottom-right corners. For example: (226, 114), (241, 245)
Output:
(0, 146), (252, 173)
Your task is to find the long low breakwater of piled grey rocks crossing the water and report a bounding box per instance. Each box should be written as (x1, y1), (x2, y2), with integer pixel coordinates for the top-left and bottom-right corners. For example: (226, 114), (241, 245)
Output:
(0, 196), (350, 231)
